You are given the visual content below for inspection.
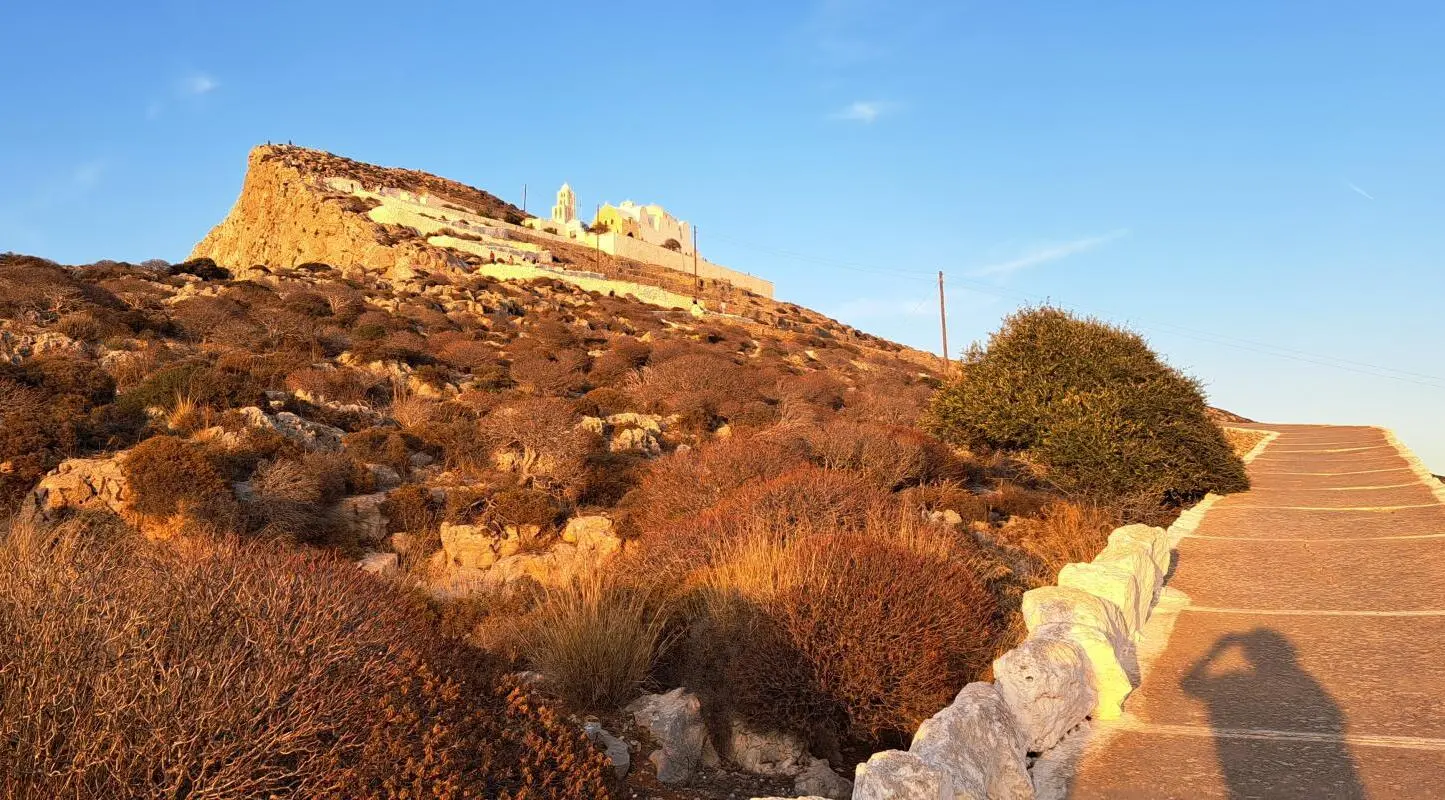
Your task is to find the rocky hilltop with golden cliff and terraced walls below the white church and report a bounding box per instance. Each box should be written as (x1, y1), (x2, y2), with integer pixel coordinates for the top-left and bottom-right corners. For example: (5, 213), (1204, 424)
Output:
(191, 144), (855, 342)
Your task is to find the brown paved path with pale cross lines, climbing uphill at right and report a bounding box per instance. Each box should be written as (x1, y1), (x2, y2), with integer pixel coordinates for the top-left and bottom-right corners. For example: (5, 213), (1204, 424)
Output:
(1069, 426), (1445, 800)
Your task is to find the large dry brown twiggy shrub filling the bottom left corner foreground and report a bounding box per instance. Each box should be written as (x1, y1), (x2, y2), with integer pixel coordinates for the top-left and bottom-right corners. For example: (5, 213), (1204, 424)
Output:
(0, 518), (611, 800)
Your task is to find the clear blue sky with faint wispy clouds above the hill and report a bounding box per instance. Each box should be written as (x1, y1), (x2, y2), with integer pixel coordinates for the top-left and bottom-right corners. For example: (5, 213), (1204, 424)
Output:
(0, 0), (1445, 472)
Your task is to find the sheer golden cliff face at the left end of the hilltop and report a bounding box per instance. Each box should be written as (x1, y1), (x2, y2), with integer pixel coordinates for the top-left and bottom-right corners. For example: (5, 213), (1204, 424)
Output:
(191, 144), (449, 279)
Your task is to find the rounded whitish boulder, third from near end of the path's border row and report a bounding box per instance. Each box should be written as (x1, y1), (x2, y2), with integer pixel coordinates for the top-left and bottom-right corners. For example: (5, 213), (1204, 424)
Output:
(994, 637), (1098, 752)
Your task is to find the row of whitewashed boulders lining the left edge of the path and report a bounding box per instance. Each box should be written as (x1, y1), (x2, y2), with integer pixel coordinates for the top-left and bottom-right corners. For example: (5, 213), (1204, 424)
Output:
(853, 432), (1283, 800)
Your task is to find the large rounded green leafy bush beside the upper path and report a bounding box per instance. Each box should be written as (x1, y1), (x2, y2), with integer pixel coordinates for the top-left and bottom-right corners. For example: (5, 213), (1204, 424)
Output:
(929, 306), (1248, 508)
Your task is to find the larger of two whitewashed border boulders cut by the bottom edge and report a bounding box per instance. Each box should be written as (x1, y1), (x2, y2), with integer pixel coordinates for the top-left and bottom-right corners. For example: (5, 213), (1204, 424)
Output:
(909, 683), (1033, 800)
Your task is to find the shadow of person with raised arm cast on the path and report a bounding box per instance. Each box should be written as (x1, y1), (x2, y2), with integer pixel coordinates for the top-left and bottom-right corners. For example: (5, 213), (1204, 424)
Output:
(1179, 628), (1366, 800)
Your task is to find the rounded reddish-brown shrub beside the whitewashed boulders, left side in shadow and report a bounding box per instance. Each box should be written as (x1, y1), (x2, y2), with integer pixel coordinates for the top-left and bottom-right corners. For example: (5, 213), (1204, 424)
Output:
(704, 517), (996, 747)
